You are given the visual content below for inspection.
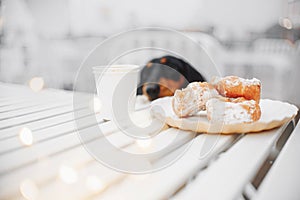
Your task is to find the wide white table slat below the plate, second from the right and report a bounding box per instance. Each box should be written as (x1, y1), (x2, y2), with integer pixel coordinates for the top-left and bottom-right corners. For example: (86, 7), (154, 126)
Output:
(174, 125), (287, 200)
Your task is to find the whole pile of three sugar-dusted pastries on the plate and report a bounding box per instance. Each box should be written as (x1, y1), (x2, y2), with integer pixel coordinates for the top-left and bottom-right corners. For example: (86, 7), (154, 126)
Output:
(172, 76), (261, 124)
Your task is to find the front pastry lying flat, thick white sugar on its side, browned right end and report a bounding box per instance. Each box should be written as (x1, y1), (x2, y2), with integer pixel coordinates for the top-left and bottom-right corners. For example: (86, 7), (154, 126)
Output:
(206, 97), (261, 124)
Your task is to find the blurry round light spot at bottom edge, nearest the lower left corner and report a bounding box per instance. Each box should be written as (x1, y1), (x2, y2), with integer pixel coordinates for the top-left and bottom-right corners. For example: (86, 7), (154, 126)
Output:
(20, 179), (39, 200)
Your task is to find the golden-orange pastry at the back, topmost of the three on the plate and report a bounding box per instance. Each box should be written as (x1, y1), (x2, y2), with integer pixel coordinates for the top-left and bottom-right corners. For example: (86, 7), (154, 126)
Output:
(211, 76), (261, 102)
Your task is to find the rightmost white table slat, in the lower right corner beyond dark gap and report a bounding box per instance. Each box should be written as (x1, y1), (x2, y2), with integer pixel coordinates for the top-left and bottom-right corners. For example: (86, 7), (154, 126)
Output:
(254, 123), (300, 200)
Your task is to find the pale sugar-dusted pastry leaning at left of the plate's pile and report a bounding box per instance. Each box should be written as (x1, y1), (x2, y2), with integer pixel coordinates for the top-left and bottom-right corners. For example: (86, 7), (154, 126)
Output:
(172, 82), (219, 117)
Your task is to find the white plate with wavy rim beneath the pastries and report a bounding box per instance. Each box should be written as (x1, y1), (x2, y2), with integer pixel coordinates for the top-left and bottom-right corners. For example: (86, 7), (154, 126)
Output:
(151, 97), (298, 134)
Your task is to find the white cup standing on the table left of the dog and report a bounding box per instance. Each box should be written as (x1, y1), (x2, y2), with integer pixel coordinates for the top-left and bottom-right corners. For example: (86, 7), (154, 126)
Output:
(93, 65), (140, 120)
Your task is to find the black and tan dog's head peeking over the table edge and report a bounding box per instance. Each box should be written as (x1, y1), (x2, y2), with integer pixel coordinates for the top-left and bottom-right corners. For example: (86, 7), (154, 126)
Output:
(138, 56), (204, 101)
